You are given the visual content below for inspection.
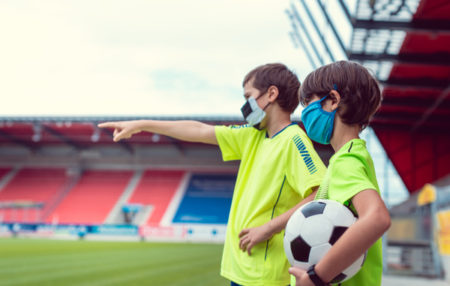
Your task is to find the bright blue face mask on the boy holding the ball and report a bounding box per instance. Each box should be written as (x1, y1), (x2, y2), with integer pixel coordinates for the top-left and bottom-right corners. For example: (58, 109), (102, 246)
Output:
(301, 95), (337, 144)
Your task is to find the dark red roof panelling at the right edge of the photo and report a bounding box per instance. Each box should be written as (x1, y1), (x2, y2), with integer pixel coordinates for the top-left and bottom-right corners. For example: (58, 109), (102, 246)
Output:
(372, 0), (450, 192)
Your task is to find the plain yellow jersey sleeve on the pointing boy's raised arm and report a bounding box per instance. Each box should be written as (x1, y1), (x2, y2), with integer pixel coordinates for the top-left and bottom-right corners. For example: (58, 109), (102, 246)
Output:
(215, 125), (253, 161)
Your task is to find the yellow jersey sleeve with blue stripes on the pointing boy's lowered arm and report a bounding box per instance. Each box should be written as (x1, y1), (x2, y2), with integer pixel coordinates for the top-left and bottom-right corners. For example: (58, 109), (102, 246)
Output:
(286, 134), (326, 198)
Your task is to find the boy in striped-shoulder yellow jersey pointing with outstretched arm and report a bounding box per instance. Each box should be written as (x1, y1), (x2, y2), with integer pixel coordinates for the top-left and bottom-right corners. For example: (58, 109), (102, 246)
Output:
(99, 64), (326, 286)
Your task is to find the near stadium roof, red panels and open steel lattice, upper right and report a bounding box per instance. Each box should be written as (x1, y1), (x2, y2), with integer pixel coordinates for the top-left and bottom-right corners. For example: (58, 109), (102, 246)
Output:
(287, 0), (450, 192)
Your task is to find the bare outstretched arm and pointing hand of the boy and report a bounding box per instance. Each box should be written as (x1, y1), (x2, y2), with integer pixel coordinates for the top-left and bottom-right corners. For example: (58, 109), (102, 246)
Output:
(98, 120), (218, 145)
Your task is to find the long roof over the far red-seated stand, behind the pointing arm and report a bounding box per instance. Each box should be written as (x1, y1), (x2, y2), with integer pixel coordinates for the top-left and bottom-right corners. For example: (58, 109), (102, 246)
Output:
(0, 116), (332, 163)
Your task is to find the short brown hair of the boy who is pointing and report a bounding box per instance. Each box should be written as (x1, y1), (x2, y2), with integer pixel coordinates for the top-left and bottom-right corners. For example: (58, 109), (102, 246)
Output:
(242, 63), (300, 113)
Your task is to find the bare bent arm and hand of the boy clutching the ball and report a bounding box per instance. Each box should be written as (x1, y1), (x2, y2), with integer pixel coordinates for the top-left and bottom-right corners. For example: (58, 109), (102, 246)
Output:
(289, 189), (391, 285)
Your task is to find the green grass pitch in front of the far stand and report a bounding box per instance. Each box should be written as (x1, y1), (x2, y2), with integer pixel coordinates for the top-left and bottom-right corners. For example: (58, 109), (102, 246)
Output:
(0, 239), (229, 286)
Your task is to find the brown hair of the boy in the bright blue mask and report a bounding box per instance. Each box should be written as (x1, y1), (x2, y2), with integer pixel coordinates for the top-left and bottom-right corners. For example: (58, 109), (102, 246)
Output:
(300, 61), (382, 129)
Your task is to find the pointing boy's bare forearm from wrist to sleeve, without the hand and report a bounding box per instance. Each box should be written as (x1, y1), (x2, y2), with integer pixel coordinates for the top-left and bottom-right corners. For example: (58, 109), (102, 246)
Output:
(135, 120), (218, 145)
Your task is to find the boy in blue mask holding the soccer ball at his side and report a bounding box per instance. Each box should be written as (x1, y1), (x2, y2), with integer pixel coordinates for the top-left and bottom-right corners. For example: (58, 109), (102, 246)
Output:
(289, 61), (390, 286)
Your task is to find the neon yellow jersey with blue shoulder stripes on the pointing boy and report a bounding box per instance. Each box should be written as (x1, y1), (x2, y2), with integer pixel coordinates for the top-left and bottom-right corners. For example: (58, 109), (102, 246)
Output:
(215, 124), (326, 286)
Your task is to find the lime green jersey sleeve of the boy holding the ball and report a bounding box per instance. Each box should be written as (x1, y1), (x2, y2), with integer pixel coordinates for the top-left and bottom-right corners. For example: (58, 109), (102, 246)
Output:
(329, 153), (378, 203)
